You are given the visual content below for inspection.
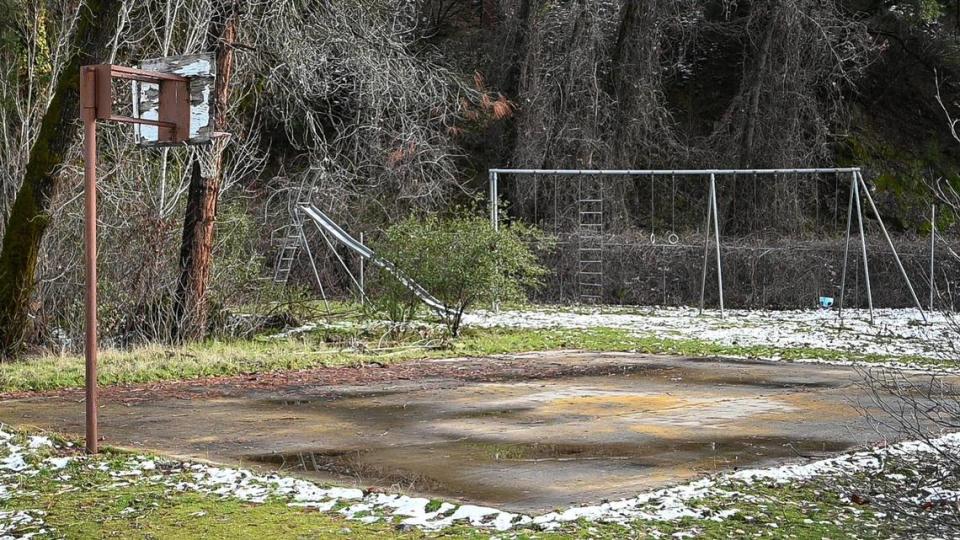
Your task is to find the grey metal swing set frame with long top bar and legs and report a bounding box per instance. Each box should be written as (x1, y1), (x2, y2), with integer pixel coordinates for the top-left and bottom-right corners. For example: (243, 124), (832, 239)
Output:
(488, 167), (927, 324)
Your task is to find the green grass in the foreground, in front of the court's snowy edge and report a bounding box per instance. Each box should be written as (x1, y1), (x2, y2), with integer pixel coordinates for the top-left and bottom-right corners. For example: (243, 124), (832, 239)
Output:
(0, 434), (894, 540)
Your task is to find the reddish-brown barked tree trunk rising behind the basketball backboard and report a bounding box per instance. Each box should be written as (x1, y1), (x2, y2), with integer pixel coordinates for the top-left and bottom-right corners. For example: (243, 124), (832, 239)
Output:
(174, 0), (241, 341)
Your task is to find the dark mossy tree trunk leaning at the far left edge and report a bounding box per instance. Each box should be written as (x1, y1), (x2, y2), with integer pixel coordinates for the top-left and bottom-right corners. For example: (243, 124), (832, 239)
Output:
(0, 0), (121, 357)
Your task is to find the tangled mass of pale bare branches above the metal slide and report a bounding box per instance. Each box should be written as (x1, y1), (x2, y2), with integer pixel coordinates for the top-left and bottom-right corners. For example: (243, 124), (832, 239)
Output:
(251, 2), (484, 223)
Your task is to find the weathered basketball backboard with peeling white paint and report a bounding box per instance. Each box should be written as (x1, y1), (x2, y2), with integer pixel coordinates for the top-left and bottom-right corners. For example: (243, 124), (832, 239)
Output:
(132, 53), (217, 147)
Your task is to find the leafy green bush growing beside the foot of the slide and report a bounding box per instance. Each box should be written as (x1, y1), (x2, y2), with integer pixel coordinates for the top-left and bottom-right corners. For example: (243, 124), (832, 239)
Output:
(373, 210), (548, 336)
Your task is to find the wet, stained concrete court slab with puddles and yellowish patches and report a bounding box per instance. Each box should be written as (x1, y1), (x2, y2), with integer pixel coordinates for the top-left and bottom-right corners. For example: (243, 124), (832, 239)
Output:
(0, 352), (936, 512)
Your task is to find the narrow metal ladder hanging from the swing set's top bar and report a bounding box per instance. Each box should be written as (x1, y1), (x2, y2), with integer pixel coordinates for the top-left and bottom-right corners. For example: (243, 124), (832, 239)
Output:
(577, 178), (603, 304)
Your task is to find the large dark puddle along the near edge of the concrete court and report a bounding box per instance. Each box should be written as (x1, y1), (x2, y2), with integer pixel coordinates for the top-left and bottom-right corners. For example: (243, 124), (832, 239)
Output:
(244, 437), (851, 510)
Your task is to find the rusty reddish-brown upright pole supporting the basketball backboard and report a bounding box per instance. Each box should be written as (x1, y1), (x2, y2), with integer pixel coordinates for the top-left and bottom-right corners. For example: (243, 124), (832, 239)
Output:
(80, 67), (97, 454)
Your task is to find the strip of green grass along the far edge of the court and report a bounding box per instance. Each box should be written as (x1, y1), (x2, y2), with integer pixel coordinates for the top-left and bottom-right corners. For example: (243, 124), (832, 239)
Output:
(0, 322), (937, 392)
